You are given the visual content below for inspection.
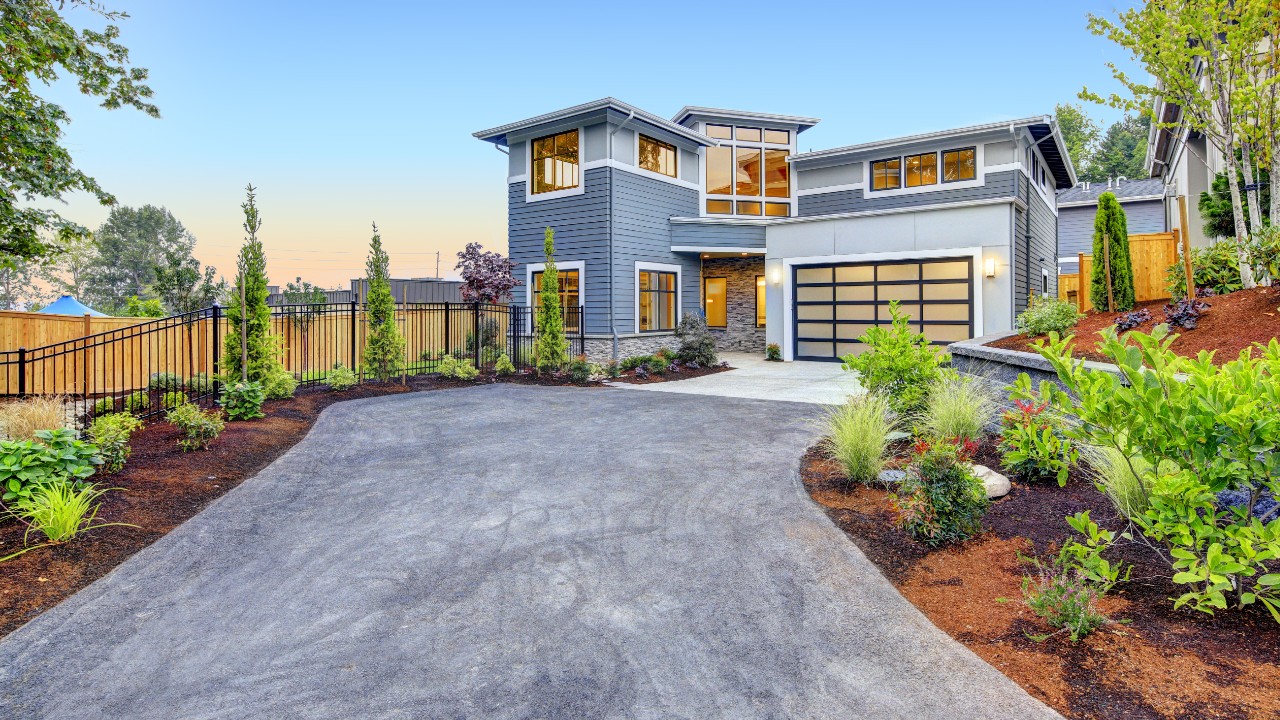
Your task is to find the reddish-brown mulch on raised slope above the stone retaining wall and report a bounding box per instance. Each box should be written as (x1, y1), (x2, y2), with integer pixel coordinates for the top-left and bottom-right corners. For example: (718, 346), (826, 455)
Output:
(988, 286), (1280, 365)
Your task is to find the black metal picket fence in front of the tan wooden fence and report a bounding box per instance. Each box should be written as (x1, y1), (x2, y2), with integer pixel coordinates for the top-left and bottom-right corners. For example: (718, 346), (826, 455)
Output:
(0, 302), (585, 416)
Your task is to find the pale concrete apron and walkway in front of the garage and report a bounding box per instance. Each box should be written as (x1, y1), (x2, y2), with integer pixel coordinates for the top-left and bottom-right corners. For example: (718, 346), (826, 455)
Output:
(614, 352), (863, 405)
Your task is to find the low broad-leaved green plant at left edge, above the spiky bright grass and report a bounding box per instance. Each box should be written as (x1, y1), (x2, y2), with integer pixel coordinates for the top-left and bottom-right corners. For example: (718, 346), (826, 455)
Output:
(0, 428), (102, 502)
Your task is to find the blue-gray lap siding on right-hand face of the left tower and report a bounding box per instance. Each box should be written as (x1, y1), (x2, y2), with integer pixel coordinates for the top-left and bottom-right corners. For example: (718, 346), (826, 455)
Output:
(602, 168), (701, 334)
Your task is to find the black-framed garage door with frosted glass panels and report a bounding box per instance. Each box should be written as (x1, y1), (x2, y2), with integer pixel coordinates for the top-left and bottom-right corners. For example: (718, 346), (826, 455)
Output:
(791, 258), (973, 360)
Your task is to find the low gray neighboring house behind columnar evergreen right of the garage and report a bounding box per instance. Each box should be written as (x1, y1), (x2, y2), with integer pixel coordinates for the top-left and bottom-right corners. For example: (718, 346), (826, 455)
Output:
(1057, 177), (1169, 274)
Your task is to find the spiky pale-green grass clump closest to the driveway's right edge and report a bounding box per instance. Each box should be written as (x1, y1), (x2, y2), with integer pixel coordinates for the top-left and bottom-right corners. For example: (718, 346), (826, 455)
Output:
(822, 393), (896, 483)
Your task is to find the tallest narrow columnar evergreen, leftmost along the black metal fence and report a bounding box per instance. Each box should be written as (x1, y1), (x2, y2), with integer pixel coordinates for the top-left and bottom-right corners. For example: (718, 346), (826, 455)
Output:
(223, 184), (278, 382)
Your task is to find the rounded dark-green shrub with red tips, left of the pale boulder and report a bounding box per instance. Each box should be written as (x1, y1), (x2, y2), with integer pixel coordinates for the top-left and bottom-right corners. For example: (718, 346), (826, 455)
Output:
(890, 441), (988, 547)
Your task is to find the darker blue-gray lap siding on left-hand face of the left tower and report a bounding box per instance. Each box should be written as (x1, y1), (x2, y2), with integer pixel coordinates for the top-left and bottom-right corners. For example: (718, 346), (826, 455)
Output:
(507, 168), (609, 333)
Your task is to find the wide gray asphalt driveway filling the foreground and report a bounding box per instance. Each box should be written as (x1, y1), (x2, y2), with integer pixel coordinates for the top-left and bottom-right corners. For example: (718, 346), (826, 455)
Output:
(0, 386), (1056, 720)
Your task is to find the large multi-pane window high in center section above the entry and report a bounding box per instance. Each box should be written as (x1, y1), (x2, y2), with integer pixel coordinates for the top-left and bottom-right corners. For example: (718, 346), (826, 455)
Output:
(704, 124), (792, 218)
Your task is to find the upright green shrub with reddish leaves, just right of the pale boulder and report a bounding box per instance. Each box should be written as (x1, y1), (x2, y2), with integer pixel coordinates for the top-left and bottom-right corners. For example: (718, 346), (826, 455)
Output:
(1000, 373), (1079, 486)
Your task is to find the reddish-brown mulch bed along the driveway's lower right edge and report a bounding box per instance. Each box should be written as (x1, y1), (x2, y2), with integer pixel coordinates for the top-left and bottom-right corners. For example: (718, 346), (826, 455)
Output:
(801, 435), (1280, 719)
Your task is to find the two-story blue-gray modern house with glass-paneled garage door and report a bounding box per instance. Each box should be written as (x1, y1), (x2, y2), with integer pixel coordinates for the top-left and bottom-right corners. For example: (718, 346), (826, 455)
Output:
(475, 97), (1075, 360)
